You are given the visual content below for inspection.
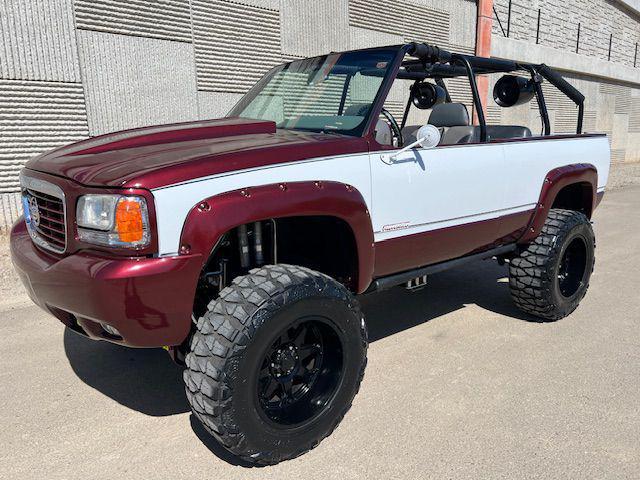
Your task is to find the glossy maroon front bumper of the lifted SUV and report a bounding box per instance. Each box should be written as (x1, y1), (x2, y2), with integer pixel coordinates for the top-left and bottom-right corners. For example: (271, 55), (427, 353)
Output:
(11, 218), (202, 347)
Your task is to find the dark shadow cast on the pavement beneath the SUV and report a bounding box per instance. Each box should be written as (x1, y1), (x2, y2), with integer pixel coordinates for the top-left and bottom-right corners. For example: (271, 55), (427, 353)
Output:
(64, 261), (535, 466)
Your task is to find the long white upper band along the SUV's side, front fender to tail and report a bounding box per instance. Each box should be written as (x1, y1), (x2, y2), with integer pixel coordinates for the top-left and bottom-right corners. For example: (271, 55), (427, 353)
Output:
(153, 137), (610, 255)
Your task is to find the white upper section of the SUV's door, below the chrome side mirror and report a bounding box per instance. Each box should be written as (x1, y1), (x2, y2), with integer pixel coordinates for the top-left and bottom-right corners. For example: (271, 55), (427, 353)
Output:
(371, 145), (507, 241)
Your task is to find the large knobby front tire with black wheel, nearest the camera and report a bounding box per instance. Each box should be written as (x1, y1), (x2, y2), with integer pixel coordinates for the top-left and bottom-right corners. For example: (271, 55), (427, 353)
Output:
(184, 265), (367, 465)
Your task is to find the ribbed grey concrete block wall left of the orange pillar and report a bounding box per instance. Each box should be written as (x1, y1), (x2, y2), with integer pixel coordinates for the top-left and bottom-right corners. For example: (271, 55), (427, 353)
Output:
(0, 0), (475, 231)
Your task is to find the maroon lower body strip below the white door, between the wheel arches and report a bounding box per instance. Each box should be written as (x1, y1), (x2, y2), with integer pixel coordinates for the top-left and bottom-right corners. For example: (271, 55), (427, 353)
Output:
(374, 211), (532, 277)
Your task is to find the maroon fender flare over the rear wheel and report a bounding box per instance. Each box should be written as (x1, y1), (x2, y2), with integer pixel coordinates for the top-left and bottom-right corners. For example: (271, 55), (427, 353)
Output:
(518, 163), (598, 243)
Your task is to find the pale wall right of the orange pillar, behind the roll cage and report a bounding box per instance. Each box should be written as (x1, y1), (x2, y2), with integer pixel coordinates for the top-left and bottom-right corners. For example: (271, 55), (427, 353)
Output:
(489, 0), (640, 165)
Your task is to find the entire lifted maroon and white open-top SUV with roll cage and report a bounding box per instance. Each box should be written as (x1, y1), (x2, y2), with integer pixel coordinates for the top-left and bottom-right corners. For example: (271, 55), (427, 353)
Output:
(11, 43), (610, 464)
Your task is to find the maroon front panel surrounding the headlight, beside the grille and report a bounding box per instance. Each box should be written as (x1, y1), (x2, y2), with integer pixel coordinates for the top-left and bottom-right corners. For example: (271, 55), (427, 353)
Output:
(24, 169), (158, 257)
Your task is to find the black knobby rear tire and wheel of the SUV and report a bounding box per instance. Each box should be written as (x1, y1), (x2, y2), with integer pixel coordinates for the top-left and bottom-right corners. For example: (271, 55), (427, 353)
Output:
(509, 209), (595, 322)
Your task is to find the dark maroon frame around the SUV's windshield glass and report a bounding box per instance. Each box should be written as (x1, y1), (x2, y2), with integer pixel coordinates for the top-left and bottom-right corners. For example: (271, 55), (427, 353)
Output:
(226, 45), (406, 137)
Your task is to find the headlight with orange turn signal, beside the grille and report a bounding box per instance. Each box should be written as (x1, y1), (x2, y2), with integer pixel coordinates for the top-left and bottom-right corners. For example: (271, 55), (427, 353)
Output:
(76, 195), (151, 247)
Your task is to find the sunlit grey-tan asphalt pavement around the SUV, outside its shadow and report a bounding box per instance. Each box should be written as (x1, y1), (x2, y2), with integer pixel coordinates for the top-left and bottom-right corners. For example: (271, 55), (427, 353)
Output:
(0, 187), (640, 480)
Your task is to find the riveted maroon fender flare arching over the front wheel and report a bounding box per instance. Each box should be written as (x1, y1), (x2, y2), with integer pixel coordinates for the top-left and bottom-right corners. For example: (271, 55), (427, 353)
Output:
(180, 181), (374, 293)
